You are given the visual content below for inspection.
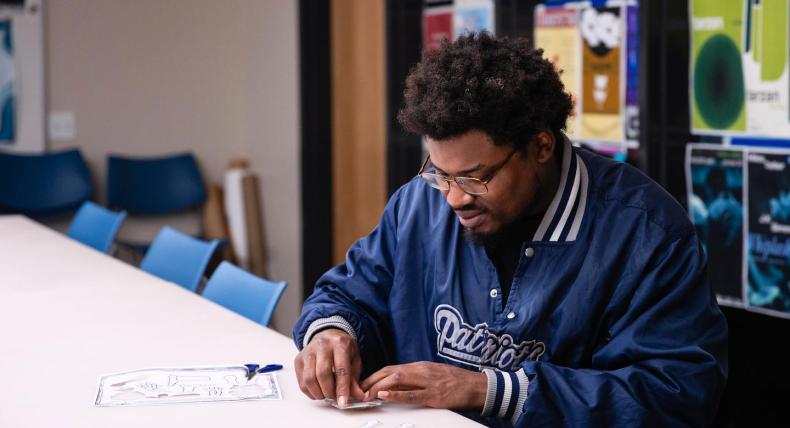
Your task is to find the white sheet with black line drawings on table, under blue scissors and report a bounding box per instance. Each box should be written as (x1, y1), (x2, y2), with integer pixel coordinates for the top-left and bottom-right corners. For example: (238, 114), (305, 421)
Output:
(94, 366), (282, 406)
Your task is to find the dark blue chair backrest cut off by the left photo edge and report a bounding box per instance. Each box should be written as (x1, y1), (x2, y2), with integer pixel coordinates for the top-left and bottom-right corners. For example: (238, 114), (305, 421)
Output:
(0, 149), (93, 216)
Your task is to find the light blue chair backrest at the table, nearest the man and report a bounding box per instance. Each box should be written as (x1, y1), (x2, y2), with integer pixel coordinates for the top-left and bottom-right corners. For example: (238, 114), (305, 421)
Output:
(203, 262), (288, 326)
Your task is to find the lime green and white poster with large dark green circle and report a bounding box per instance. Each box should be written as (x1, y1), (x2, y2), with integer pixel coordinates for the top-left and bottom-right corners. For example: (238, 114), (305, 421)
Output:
(689, 0), (790, 138)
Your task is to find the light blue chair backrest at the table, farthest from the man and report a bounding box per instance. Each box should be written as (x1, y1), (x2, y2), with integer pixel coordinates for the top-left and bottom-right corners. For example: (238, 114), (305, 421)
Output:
(66, 201), (126, 253)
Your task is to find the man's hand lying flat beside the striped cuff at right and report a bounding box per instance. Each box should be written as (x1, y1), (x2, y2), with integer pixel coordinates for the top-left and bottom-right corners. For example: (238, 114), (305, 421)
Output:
(362, 361), (488, 410)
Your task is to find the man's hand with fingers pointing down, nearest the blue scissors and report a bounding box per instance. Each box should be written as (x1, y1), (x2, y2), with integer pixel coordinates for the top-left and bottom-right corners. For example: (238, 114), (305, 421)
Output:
(294, 328), (363, 406)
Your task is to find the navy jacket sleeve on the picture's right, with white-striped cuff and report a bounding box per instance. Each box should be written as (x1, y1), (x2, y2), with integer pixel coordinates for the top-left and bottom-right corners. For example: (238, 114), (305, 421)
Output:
(489, 230), (727, 427)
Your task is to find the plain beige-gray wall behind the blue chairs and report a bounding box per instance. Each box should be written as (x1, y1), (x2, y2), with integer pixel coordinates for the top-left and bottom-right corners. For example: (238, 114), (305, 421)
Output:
(45, 0), (302, 333)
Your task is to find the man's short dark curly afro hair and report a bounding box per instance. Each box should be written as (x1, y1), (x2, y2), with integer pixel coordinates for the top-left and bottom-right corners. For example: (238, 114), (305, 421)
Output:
(398, 32), (573, 148)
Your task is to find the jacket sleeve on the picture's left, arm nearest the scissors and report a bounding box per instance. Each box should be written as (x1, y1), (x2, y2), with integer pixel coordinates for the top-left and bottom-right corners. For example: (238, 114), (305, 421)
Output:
(293, 191), (401, 376)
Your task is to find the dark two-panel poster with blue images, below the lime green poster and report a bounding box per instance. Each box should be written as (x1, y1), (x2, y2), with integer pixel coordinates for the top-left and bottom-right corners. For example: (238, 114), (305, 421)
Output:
(686, 144), (790, 318)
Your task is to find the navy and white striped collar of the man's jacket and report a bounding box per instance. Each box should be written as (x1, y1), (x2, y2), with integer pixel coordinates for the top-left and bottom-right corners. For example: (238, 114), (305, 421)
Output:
(532, 136), (589, 242)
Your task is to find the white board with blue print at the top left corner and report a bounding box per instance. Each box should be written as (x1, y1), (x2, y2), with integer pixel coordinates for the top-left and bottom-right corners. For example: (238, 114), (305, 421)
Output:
(0, 0), (46, 153)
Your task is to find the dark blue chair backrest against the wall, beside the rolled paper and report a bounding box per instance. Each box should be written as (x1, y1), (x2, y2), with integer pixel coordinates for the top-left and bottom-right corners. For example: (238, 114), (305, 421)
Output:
(107, 153), (206, 214)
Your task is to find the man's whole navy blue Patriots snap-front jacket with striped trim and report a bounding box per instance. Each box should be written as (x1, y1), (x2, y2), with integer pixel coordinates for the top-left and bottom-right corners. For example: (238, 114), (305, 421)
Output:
(294, 140), (727, 427)
